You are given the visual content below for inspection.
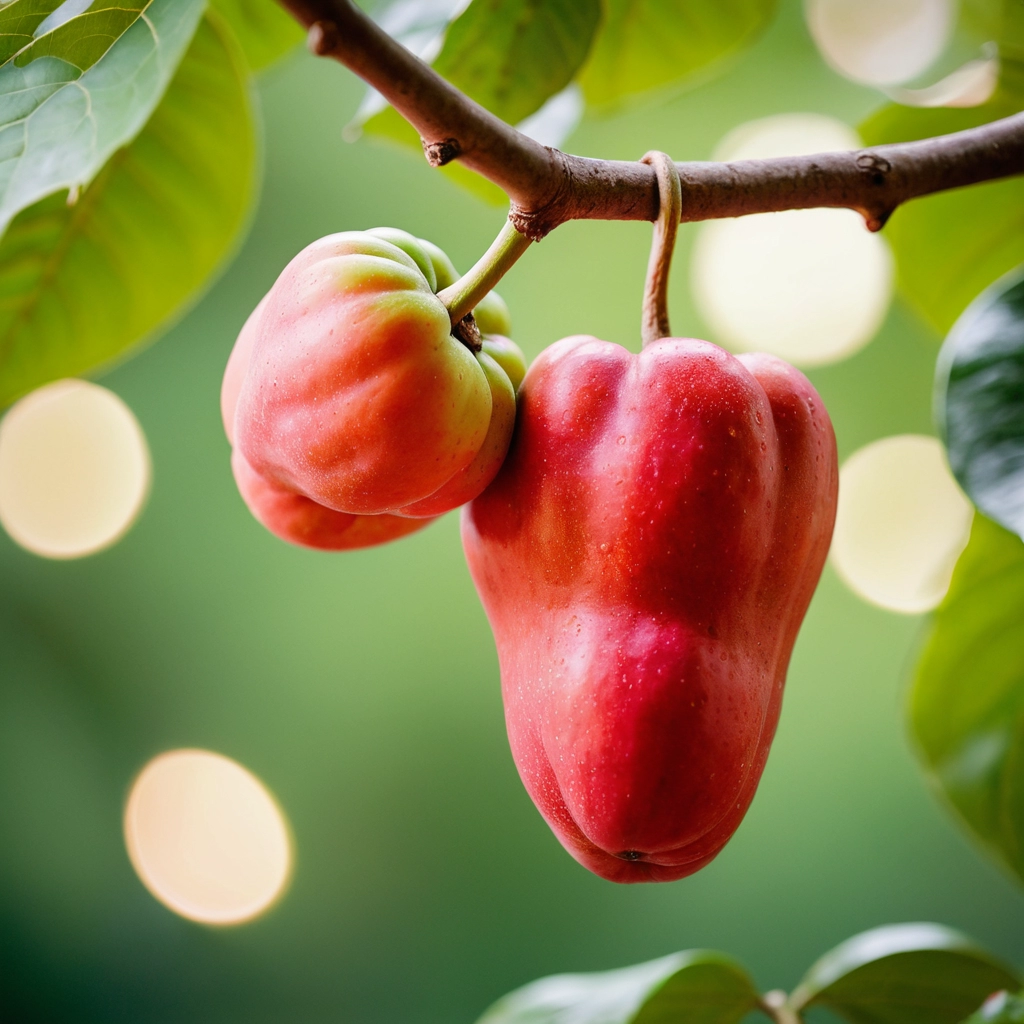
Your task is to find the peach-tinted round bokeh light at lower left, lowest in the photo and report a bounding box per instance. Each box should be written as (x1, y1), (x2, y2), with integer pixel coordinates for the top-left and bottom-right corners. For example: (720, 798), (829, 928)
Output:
(125, 750), (292, 925)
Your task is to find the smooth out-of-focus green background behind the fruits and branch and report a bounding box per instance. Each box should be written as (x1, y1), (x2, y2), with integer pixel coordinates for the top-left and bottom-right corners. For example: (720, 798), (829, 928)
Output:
(0, 3), (1024, 1024)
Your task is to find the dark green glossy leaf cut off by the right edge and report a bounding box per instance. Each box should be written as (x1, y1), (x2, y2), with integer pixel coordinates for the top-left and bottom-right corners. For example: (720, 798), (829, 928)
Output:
(936, 272), (1024, 537)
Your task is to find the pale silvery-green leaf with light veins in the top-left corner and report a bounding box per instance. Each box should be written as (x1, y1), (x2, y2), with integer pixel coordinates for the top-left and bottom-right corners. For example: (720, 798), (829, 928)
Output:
(0, 0), (204, 232)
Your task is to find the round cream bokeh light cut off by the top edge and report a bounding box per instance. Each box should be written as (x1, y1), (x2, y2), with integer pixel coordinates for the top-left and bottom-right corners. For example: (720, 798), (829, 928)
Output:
(805, 0), (955, 85)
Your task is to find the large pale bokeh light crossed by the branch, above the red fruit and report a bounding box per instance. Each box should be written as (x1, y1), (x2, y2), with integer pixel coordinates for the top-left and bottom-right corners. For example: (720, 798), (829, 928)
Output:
(691, 114), (893, 367)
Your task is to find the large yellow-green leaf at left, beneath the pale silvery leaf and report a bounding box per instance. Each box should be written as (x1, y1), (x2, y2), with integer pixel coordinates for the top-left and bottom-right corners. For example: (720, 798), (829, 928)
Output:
(0, 12), (257, 404)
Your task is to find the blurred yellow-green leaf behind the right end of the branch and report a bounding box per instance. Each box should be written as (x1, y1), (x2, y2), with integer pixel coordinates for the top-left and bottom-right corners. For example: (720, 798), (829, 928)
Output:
(860, 47), (1024, 334)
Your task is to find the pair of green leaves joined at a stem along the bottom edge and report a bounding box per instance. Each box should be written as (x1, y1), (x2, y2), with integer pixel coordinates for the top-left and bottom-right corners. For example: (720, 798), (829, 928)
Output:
(478, 924), (1021, 1024)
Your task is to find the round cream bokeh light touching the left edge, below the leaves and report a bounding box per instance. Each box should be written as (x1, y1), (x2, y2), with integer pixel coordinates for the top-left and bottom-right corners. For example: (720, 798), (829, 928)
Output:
(0, 380), (151, 558)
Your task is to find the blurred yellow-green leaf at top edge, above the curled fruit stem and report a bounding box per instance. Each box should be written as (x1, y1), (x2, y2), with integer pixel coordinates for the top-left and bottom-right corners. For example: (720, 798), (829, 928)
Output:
(580, 0), (775, 106)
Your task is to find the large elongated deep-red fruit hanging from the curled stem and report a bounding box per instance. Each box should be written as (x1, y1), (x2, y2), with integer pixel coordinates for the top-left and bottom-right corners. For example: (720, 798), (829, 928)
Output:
(462, 337), (839, 882)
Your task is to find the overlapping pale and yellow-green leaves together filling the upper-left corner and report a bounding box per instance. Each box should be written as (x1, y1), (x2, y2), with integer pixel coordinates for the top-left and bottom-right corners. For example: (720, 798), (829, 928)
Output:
(0, 0), (301, 406)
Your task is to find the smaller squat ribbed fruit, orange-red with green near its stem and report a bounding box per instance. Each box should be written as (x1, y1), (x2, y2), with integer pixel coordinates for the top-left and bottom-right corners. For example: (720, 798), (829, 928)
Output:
(221, 228), (524, 550)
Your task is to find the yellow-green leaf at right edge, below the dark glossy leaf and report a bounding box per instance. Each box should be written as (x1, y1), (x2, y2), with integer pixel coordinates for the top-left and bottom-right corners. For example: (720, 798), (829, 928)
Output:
(909, 514), (1024, 884)
